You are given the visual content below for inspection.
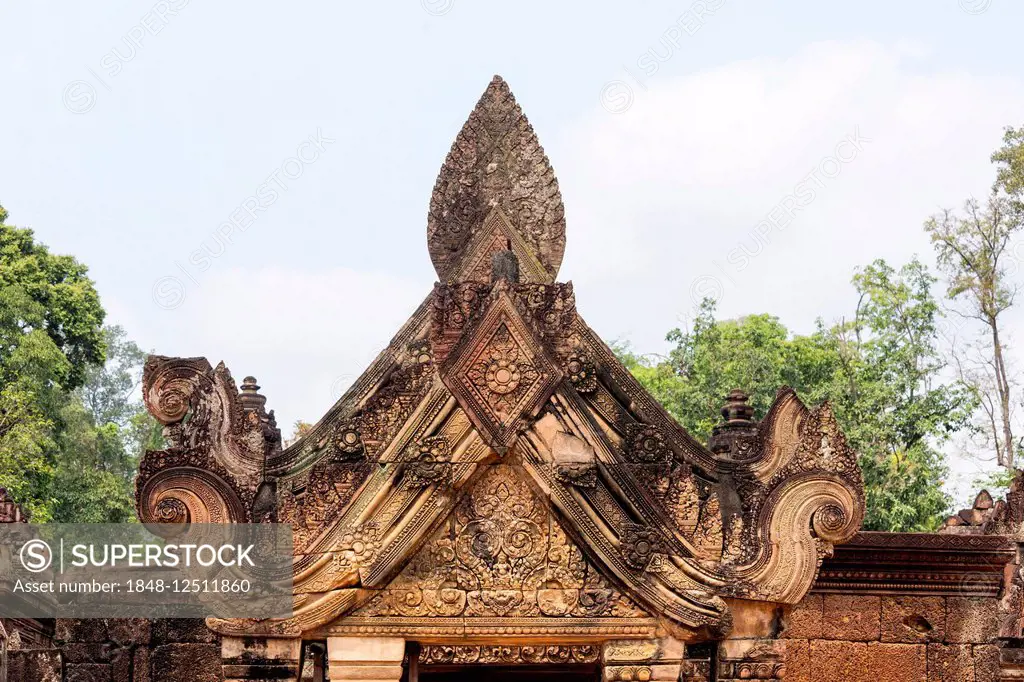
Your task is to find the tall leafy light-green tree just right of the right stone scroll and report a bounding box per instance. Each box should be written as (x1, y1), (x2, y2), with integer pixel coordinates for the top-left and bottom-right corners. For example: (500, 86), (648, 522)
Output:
(829, 260), (977, 530)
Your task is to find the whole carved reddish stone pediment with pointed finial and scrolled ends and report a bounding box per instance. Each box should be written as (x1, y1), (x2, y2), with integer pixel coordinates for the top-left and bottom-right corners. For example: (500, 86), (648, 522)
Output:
(137, 78), (864, 643)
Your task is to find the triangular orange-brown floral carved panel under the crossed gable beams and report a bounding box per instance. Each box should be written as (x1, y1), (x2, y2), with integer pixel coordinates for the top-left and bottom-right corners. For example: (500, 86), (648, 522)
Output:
(328, 464), (654, 635)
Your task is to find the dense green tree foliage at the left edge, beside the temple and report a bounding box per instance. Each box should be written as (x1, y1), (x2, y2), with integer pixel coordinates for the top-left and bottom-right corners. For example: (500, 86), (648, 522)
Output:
(0, 208), (159, 522)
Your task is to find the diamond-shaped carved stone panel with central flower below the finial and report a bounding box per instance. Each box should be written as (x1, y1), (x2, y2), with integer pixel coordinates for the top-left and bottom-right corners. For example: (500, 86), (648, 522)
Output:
(442, 293), (561, 450)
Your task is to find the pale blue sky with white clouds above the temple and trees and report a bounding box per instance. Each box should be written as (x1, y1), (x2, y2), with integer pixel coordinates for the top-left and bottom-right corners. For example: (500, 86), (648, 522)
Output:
(0, 0), (1024, 499)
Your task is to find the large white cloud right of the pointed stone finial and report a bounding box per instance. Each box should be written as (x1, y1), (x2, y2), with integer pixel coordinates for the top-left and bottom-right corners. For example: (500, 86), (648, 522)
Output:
(552, 41), (1024, 350)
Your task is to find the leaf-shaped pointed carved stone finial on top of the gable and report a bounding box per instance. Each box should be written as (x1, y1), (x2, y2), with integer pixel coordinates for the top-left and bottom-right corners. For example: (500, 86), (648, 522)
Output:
(427, 76), (565, 282)
